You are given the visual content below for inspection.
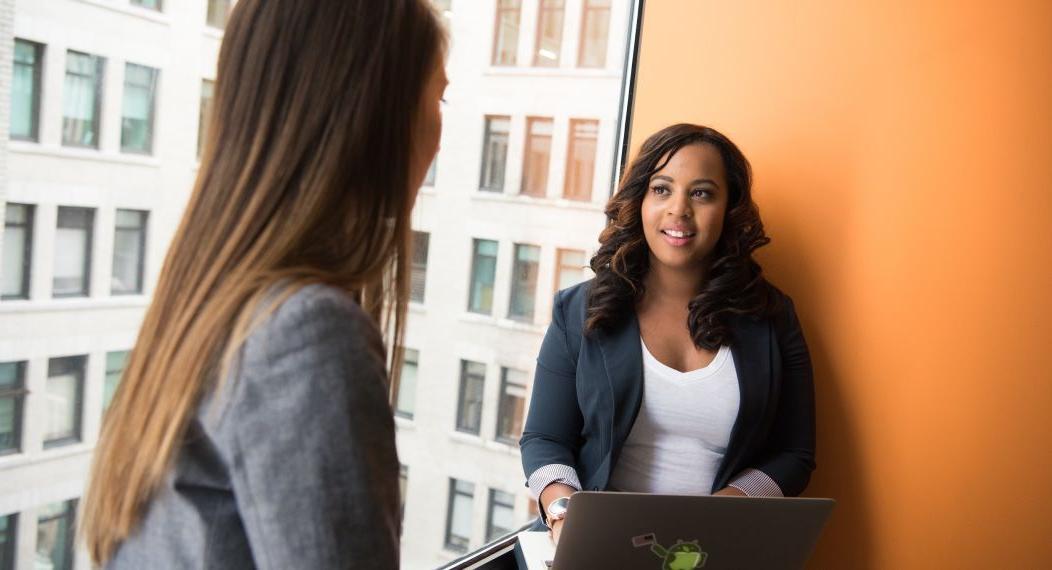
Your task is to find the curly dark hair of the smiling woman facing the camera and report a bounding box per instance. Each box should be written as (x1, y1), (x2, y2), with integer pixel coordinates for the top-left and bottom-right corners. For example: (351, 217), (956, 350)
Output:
(585, 123), (780, 350)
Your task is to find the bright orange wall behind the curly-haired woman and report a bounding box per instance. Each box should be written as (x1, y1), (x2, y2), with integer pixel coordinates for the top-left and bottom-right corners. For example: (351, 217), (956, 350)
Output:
(632, 0), (1052, 569)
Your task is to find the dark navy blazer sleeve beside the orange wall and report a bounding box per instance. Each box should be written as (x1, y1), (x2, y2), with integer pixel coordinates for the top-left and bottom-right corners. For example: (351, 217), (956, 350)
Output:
(751, 296), (815, 496)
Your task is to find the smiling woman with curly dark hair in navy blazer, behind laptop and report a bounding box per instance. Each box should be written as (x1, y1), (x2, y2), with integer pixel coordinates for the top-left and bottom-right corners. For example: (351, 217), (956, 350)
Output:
(520, 124), (814, 541)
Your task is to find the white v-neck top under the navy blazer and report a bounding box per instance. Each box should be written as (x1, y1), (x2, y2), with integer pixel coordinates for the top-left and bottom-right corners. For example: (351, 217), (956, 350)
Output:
(610, 339), (741, 495)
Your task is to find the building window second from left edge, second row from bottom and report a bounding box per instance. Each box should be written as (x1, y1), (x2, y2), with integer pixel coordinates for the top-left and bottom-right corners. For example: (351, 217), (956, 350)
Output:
(44, 355), (87, 448)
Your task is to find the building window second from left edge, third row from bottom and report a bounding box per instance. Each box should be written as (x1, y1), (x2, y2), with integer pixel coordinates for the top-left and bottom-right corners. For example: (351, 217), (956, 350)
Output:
(52, 206), (95, 297)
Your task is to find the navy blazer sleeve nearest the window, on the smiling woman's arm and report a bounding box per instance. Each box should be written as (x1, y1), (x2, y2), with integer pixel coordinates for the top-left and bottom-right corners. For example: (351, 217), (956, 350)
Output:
(519, 293), (584, 494)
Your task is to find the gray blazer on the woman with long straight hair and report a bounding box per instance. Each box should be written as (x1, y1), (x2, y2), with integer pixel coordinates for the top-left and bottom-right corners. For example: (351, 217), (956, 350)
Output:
(106, 285), (401, 570)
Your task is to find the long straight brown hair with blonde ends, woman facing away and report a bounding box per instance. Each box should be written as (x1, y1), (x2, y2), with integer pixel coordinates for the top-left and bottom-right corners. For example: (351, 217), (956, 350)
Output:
(83, 0), (446, 564)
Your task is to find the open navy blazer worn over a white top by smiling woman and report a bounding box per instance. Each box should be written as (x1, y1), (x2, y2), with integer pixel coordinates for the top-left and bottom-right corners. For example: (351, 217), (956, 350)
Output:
(519, 281), (814, 504)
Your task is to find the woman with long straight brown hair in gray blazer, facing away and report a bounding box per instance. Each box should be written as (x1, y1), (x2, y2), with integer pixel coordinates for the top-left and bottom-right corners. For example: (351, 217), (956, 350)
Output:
(82, 0), (446, 568)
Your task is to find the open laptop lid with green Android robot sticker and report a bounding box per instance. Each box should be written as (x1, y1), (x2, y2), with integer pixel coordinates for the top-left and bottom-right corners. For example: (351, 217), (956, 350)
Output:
(551, 492), (833, 570)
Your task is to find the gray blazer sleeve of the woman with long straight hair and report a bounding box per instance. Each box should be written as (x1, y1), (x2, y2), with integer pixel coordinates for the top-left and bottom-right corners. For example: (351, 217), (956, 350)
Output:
(223, 286), (400, 569)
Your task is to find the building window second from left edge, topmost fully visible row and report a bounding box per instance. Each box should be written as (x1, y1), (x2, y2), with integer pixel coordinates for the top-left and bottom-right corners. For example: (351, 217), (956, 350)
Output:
(62, 52), (106, 148)
